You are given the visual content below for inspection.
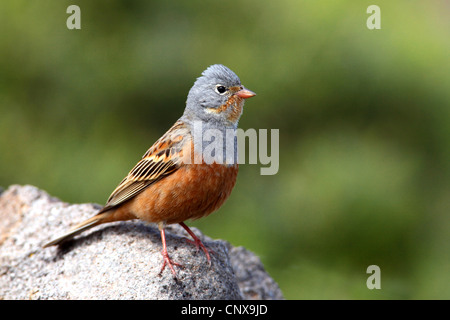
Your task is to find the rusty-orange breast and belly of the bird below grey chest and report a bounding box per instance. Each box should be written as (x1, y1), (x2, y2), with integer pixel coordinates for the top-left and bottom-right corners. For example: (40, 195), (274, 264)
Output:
(123, 163), (238, 224)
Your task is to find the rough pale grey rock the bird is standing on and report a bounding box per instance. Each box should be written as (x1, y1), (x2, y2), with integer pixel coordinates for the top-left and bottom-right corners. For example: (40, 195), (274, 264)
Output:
(0, 185), (283, 299)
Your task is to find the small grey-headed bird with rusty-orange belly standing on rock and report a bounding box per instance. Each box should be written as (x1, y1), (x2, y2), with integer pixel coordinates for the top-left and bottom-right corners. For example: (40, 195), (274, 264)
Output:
(44, 64), (255, 278)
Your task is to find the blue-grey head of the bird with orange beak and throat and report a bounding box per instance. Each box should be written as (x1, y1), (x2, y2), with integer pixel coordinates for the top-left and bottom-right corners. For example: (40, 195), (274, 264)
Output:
(182, 64), (255, 128)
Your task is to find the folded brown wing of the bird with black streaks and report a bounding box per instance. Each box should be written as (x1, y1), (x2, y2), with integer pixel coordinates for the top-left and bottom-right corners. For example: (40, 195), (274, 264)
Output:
(101, 121), (189, 211)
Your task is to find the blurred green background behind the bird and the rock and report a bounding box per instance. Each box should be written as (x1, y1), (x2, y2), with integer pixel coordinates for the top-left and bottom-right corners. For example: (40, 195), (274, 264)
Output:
(0, 0), (450, 299)
